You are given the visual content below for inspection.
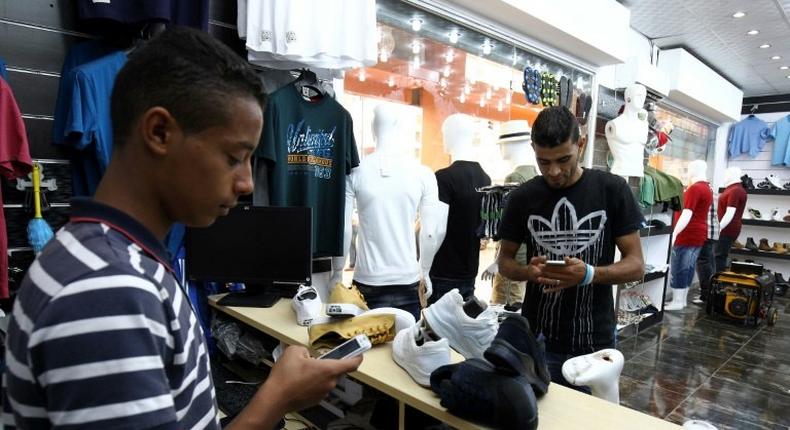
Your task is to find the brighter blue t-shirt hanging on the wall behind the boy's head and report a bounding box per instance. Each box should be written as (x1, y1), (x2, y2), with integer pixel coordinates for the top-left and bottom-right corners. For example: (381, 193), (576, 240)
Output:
(64, 52), (127, 195)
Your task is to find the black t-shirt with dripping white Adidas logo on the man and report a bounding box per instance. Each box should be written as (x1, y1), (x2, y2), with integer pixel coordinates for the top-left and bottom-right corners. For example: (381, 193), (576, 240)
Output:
(500, 169), (643, 354)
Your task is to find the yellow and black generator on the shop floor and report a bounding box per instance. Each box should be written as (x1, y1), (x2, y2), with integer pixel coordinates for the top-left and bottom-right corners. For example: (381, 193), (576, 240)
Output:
(706, 270), (779, 326)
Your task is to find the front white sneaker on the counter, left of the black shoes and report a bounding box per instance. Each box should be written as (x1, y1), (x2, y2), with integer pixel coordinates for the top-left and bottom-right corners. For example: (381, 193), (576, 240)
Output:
(392, 324), (450, 387)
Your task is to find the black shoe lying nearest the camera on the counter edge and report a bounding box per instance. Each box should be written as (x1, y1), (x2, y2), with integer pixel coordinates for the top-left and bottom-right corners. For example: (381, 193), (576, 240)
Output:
(431, 358), (540, 430)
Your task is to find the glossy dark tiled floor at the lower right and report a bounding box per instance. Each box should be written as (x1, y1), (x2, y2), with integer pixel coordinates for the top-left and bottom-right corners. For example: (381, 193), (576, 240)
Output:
(618, 294), (790, 430)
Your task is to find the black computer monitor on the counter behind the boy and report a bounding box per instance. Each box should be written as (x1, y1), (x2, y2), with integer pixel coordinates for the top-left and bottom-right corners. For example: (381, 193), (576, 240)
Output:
(185, 206), (312, 307)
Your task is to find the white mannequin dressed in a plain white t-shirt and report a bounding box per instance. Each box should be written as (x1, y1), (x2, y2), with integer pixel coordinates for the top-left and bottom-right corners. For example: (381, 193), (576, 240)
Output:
(332, 104), (447, 298)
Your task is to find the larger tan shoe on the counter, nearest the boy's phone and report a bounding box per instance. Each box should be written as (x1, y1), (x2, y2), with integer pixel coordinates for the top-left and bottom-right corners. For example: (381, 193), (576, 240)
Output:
(307, 312), (395, 351)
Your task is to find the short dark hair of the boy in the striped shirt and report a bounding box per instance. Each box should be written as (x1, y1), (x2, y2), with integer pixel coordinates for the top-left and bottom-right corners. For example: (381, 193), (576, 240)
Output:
(111, 27), (263, 146)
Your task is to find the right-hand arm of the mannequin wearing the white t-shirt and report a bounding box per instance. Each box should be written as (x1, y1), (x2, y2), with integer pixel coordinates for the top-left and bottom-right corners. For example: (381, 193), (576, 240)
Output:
(420, 199), (450, 299)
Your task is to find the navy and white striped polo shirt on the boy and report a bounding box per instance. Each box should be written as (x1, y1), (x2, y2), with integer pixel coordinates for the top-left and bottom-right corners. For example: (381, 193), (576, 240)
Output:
(3, 199), (219, 429)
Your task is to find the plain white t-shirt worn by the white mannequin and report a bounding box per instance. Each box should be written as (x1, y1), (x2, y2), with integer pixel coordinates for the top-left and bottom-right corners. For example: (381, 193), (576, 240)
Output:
(346, 152), (439, 285)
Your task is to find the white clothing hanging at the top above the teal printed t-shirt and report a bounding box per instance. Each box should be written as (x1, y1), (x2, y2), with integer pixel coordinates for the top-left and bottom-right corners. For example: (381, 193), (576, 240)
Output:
(237, 0), (377, 69)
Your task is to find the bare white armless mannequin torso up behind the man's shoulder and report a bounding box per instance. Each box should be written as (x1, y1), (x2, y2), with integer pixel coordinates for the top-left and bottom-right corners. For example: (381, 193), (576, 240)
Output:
(606, 84), (648, 177)
